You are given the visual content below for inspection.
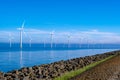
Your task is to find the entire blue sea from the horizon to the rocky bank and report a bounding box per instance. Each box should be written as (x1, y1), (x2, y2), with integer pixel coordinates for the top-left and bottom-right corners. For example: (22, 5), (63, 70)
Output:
(0, 43), (120, 72)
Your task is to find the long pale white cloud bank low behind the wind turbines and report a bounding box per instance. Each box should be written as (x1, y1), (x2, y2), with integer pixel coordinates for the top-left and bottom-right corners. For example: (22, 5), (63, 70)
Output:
(0, 29), (120, 43)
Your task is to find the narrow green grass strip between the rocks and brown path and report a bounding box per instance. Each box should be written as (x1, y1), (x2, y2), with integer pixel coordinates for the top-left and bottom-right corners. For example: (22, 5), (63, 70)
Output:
(54, 56), (113, 80)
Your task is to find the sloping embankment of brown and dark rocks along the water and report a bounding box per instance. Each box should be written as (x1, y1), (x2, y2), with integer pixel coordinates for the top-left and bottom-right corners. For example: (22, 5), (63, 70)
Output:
(0, 51), (120, 80)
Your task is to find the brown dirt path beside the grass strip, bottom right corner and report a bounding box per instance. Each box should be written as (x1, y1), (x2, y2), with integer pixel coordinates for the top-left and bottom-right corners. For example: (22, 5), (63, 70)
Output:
(70, 55), (120, 80)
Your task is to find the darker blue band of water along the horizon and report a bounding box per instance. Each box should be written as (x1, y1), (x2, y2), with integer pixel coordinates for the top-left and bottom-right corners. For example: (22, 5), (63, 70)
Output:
(0, 43), (120, 52)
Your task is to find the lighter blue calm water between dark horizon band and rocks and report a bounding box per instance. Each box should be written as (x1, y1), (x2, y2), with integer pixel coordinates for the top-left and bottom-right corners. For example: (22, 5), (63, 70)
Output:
(0, 49), (118, 72)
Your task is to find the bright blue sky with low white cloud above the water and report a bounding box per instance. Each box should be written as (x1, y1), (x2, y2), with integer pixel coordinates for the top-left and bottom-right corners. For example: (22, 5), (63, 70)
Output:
(0, 0), (120, 42)
